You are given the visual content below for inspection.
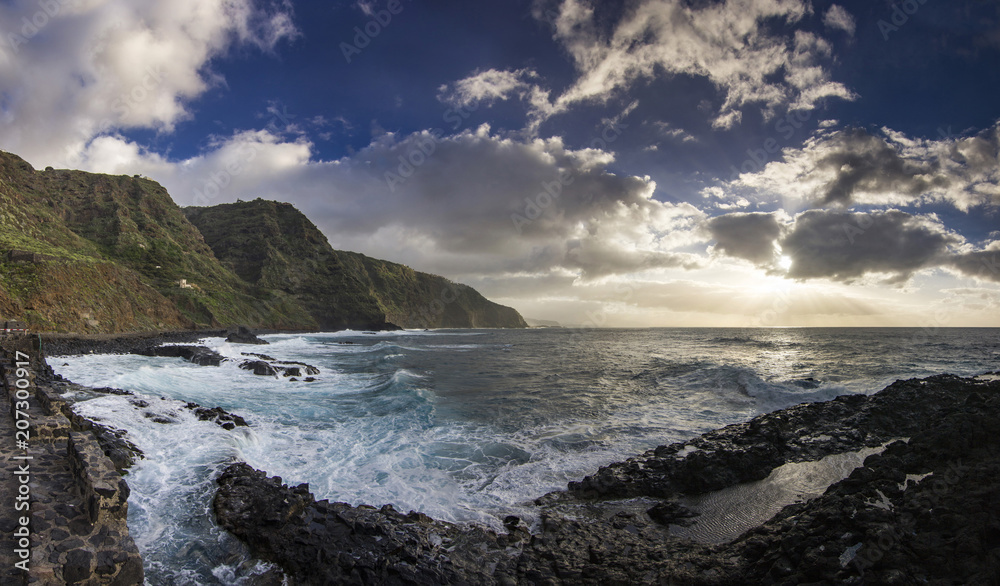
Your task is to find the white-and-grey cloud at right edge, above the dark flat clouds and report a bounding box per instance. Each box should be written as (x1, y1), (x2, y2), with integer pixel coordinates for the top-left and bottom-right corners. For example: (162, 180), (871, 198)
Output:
(729, 123), (1000, 211)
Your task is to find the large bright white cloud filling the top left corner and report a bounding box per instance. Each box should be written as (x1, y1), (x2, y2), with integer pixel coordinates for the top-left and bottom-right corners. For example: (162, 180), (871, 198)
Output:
(0, 0), (298, 166)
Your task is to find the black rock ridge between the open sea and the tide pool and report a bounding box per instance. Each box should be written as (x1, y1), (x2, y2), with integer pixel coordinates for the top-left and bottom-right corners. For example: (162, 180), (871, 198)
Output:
(569, 376), (980, 498)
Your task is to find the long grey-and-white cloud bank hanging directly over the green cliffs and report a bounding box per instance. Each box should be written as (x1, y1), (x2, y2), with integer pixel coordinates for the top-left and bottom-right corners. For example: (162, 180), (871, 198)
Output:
(87, 126), (704, 279)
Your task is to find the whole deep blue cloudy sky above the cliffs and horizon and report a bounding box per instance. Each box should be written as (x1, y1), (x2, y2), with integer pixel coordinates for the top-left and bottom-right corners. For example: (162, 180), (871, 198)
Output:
(0, 0), (1000, 324)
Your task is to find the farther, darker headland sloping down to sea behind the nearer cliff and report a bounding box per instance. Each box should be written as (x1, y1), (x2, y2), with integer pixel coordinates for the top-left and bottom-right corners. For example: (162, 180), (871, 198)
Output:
(184, 199), (526, 329)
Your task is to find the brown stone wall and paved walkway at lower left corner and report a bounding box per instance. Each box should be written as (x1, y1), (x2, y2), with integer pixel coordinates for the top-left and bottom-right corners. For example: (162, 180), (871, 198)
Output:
(0, 336), (144, 586)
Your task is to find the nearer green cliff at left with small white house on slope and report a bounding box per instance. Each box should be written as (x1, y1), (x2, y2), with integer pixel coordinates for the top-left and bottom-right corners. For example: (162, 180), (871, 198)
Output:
(0, 152), (315, 333)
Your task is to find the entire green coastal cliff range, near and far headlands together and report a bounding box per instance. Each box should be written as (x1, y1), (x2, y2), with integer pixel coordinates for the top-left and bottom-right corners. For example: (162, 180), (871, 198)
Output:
(0, 152), (525, 334)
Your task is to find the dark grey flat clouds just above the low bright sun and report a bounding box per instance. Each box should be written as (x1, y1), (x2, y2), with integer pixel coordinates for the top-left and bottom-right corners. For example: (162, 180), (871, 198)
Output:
(707, 210), (964, 284)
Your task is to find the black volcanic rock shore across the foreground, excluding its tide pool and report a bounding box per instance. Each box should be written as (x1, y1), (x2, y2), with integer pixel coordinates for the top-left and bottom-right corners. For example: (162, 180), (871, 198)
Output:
(214, 375), (1000, 585)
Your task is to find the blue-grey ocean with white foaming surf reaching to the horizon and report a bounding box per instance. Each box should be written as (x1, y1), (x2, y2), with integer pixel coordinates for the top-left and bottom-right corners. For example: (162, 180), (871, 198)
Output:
(49, 328), (1000, 585)
